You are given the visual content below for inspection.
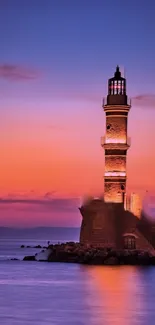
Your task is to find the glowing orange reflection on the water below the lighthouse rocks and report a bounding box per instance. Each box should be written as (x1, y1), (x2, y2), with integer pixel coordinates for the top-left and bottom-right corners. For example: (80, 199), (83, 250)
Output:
(83, 266), (143, 325)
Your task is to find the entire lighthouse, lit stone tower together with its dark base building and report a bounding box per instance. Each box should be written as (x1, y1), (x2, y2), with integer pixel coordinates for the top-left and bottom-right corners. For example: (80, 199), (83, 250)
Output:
(79, 66), (155, 254)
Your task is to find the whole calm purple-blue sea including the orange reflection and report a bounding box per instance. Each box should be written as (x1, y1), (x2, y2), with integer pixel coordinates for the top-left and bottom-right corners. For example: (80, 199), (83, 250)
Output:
(0, 228), (155, 325)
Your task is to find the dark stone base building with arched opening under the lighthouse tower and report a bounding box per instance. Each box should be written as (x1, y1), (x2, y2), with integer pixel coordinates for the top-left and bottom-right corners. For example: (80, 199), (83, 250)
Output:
(79, 199), (155, 253)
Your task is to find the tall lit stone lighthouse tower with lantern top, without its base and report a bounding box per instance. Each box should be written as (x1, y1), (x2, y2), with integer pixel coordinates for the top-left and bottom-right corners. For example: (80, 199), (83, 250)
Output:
(101, 66), (131, 202)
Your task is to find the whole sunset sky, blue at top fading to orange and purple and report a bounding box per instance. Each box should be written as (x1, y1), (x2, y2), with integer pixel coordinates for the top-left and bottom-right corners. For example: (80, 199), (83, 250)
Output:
(0, 0), (155, 227)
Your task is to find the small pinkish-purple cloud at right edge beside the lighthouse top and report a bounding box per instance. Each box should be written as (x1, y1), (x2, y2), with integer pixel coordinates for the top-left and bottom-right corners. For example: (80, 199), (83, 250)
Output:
(132, 94), (155, 109)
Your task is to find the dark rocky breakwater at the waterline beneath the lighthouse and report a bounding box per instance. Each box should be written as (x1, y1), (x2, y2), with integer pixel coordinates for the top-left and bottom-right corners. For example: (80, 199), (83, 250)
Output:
(24, 242), (155, 265)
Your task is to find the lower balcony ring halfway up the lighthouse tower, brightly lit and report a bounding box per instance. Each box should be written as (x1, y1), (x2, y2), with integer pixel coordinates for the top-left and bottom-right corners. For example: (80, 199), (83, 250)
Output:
(101, 136), (131, 149)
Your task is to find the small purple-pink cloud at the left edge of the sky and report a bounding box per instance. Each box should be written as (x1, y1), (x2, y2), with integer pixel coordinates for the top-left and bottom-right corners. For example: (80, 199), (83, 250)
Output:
(0, 64), (39, 81)
